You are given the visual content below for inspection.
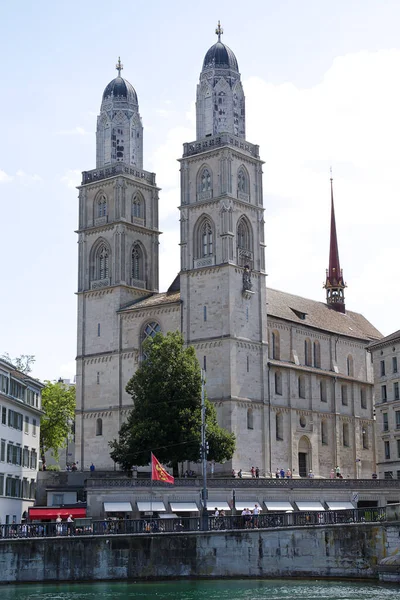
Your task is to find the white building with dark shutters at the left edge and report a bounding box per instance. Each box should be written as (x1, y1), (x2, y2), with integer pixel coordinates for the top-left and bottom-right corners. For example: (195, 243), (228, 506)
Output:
(0, 359), (44, 524)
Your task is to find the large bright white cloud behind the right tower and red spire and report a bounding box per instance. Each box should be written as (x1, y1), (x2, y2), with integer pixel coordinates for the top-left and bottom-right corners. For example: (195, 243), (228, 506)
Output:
(153, 50), (400, 333)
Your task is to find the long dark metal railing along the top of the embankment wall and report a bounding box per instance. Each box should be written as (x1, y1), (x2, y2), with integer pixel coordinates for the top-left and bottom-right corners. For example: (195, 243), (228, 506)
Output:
(0, 508), (386, 541)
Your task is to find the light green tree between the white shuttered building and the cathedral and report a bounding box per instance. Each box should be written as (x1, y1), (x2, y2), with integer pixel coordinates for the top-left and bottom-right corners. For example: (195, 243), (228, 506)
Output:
(40, 381), (75, 460)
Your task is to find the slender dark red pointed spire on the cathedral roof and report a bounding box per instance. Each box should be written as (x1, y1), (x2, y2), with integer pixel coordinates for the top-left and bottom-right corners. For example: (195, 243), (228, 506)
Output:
(324, 169), (346, 313)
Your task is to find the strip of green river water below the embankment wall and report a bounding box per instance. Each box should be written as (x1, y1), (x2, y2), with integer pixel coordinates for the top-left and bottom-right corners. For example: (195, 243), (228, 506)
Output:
(1, 579), (400, 600)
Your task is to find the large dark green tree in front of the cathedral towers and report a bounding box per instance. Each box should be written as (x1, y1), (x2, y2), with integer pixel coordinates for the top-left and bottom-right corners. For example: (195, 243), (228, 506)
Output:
(110, 332), (235, 475)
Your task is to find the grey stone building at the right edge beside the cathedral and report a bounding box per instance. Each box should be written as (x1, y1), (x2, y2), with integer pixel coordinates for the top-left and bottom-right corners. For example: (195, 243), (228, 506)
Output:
(369, 331), (400, 479)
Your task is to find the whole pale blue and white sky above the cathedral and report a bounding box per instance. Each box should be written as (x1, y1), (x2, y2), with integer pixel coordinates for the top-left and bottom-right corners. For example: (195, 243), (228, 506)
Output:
(0, 0), (400, 380)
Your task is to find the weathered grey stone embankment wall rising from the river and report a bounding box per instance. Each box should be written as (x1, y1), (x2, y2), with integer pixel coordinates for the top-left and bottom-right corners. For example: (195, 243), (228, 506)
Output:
(0, 523), (394, 583)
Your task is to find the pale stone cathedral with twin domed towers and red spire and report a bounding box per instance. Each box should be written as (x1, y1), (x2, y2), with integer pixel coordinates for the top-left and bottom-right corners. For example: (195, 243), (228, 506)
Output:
(75, 24), (381, 477)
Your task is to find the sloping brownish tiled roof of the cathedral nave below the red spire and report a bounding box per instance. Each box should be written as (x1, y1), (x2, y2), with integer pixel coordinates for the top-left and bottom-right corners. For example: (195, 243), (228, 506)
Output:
(267, 288), (382, 340)
